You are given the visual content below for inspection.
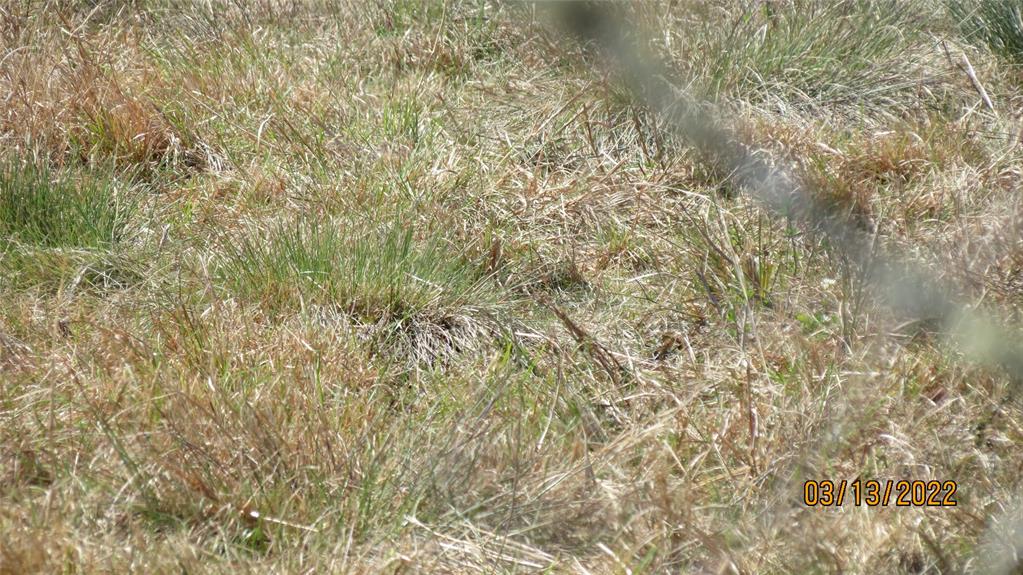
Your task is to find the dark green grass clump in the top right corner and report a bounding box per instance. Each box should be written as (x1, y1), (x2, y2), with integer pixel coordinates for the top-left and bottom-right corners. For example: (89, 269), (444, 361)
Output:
(945, 0), (1023, 63)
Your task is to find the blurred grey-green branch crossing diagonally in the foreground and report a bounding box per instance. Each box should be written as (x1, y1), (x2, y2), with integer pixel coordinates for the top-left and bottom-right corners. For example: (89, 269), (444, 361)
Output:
(542, 1), (1023, 383)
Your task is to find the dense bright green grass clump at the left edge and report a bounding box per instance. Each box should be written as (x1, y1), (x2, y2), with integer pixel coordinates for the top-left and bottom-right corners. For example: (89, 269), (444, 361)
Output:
(0, 160), (133, 249)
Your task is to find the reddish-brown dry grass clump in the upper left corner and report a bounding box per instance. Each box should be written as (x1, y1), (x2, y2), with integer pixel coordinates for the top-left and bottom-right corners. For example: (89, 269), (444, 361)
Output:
(0, 7), (203, 168)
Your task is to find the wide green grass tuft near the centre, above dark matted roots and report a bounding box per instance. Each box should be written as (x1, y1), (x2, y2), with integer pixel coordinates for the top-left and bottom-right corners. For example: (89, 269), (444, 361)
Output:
(221, 215), (495, 323)
